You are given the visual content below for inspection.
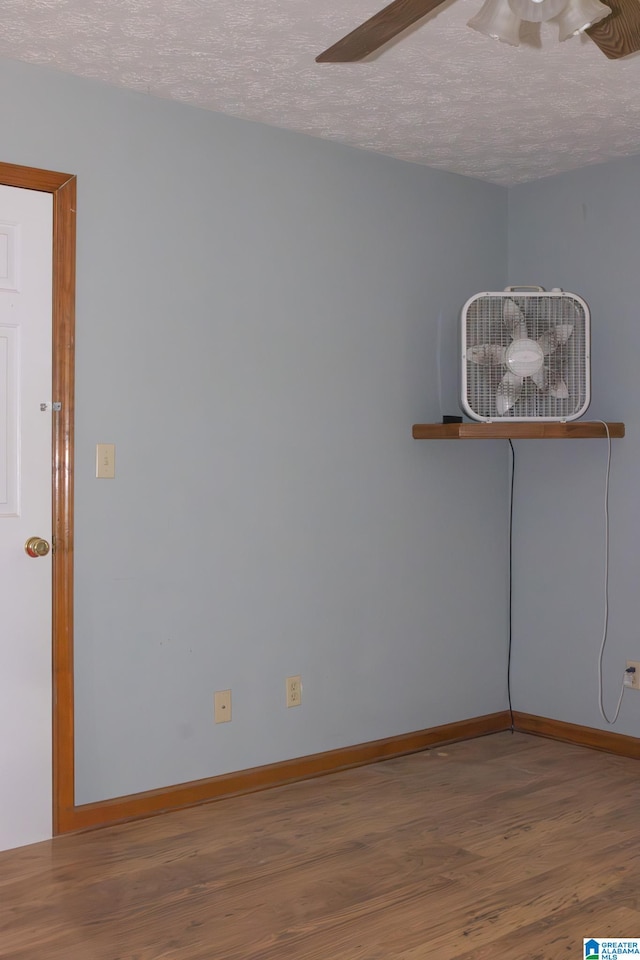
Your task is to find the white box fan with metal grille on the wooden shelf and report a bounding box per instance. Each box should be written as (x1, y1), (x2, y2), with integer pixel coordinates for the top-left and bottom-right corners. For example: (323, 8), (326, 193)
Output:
(462, 287), (591, 420)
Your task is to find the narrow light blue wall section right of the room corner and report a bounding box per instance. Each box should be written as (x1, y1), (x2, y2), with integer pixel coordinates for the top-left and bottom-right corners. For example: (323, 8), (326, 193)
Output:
(509, 157), (640, 736)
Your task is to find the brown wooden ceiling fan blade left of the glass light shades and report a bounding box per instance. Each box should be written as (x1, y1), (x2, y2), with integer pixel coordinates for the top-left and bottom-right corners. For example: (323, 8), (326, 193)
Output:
(316, 0), (444, 63)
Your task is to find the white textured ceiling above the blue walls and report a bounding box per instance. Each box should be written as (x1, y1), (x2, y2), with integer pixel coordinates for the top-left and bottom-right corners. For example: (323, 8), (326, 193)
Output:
(0, 0), (640, 185)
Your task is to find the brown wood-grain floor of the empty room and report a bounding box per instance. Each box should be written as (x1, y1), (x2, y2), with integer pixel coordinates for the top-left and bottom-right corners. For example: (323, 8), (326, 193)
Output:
(0, 733), (640, 960)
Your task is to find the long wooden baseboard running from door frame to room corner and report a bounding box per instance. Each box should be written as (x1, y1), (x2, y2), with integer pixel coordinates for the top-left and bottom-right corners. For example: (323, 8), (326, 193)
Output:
(58, 710), (510, 833)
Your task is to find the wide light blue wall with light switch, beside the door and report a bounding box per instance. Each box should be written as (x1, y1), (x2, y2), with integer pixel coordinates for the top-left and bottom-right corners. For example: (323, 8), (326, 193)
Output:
(0, 54), (507, 802)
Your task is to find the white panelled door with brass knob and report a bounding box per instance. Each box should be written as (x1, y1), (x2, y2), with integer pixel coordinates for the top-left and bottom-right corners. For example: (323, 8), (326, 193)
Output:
(0, 186), (53, 850)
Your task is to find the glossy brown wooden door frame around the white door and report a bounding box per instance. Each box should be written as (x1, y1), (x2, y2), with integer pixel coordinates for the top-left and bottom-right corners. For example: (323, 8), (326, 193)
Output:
(0, 163), (76, 835)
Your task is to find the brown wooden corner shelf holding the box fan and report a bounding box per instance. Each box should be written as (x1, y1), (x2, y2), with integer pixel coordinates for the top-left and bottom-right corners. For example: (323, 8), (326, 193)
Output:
(413, 420), (624, 440)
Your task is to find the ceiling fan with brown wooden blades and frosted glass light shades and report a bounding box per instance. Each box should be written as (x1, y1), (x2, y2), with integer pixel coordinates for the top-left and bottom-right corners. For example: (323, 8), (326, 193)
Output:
(316, 0), (640, 63)
